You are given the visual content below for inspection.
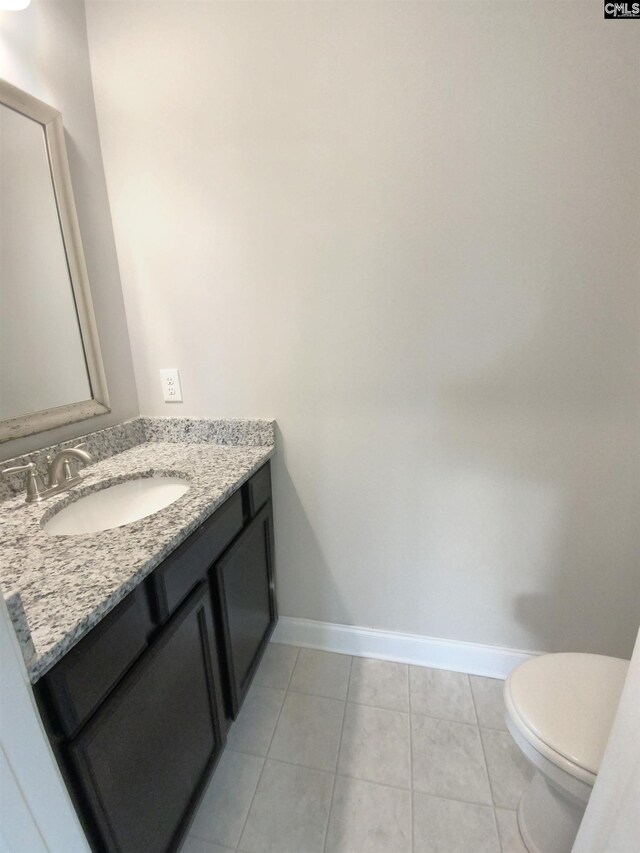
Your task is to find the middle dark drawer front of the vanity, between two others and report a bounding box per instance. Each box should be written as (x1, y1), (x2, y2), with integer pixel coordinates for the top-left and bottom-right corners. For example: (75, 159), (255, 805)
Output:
(150, 491), (243, 623)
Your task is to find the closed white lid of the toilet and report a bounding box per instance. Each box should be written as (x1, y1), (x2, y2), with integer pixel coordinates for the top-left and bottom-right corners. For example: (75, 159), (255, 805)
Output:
(505, 653), (629, 775)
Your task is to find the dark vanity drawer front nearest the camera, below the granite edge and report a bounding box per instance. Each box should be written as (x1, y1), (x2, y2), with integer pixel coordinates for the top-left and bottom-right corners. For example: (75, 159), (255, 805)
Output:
(43, 587), (152, 735)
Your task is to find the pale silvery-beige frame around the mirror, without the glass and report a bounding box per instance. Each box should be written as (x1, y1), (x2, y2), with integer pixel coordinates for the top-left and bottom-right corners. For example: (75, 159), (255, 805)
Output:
(0, 80), (111, 442)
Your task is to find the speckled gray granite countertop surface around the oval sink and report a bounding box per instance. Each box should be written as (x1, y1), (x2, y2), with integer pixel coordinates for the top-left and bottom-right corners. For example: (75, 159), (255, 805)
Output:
(0, 441), (274, 683)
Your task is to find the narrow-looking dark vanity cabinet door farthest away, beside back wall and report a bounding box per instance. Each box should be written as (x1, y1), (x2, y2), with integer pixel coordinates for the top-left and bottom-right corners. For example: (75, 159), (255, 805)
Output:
(215, 501), (276, 717)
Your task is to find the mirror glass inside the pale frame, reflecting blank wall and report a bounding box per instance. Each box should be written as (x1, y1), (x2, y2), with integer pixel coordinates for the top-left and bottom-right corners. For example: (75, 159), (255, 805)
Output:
(0, 104), (91, 420)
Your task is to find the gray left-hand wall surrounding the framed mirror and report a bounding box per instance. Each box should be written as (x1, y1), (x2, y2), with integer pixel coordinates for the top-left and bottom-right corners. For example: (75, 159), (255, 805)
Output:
(0, 0), (138, 459)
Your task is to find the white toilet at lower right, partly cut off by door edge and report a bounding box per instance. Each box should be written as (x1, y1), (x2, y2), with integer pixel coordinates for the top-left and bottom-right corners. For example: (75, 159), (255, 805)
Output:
(504, 653), (629, 853)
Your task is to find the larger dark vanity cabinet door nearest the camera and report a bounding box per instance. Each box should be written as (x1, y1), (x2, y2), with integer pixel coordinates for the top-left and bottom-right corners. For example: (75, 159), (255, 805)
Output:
(68, 583), (222, 853)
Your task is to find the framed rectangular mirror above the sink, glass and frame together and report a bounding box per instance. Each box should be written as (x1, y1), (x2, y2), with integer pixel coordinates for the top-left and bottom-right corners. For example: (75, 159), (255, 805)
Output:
(0, 80), (109, 441)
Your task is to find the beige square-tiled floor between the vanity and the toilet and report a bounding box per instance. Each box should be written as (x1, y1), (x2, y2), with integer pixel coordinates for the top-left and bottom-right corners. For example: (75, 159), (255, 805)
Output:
(182, 643), (530, 853)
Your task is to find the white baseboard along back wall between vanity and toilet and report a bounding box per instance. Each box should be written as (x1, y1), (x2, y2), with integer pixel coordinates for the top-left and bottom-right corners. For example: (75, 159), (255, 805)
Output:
(271, 616), (539, 678)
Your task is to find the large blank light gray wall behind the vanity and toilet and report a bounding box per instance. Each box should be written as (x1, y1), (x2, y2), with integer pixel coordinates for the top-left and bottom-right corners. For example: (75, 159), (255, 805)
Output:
(87, 2), (640, 654)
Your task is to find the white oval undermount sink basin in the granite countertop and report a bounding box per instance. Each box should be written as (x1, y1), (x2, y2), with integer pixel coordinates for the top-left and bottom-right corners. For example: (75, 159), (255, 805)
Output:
(44, 476), (189, 536)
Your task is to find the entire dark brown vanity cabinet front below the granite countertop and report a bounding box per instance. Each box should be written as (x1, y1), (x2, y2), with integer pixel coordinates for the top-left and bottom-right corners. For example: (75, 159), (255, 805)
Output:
(35, 463), (276, 853)
